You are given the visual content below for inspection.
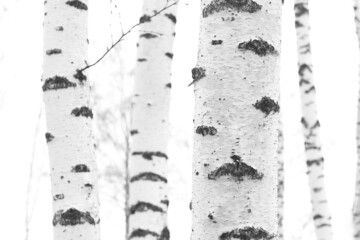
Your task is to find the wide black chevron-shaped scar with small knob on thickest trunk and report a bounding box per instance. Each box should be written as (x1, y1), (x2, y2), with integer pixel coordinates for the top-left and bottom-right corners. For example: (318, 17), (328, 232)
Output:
(208, 158), (264, 181)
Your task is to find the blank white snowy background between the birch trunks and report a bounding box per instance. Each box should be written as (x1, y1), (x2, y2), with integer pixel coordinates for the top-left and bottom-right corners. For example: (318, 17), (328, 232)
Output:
(0, 0), (359, 240)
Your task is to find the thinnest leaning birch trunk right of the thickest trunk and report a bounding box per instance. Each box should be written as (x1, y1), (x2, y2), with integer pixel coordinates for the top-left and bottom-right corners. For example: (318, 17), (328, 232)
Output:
(294, 0), (332, 240)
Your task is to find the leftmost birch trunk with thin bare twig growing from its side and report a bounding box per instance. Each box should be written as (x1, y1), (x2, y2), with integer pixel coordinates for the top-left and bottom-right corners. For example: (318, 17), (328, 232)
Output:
(42, 0), (100, 240)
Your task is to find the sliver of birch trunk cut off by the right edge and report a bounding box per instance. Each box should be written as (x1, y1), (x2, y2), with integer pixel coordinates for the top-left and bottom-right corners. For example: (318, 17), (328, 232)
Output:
(352, 0), (360, 240)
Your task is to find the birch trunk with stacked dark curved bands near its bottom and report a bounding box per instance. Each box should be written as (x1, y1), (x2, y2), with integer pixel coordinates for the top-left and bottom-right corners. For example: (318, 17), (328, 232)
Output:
(127, 0), (176, 240)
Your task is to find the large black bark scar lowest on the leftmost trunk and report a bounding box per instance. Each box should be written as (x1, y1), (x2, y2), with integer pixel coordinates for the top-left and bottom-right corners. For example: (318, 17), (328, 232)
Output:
(53, 208), (95, 226)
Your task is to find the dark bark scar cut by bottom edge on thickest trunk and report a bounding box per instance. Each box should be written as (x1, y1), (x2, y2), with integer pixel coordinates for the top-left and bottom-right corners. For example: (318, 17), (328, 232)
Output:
(219, 227), (276, 240)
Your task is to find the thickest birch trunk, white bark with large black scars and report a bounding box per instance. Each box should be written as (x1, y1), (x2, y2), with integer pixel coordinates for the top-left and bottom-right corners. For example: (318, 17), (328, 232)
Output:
(191, 0), (281, 240)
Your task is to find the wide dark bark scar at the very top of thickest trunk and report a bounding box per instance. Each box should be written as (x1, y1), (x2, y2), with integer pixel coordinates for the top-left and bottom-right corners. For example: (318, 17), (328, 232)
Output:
(203, 0), (262, 18)
